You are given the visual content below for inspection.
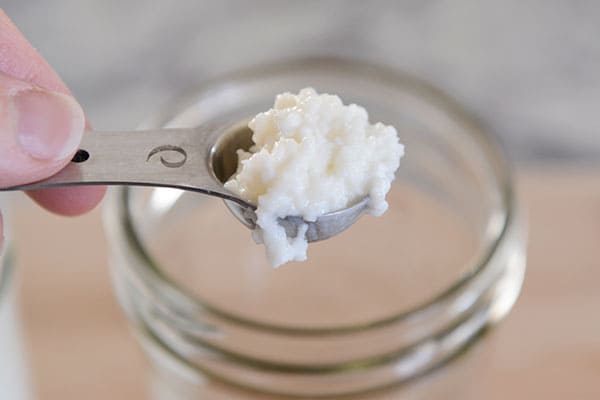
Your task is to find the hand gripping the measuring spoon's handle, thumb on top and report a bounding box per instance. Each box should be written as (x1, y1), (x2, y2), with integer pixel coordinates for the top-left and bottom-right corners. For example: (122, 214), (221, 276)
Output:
(0, 9), (105, 244)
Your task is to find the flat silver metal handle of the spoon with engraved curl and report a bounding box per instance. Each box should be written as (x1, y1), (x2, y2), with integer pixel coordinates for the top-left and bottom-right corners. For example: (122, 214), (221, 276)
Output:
(0, 128), (240, 202)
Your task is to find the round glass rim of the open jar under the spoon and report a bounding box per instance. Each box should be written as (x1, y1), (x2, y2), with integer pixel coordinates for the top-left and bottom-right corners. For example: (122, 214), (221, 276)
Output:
(106, 58), (516, 336)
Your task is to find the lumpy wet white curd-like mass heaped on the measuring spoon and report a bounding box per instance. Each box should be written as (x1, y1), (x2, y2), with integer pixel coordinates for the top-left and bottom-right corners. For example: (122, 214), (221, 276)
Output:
(225, 88), (404, 267)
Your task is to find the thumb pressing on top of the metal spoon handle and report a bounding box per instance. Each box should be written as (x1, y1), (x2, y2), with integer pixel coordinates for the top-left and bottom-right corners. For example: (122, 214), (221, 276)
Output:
(0, 73), (85, 187)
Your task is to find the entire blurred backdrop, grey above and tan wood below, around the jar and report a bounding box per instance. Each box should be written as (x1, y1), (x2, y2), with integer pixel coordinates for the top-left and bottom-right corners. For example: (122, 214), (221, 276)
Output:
(0, 0), (600, 400)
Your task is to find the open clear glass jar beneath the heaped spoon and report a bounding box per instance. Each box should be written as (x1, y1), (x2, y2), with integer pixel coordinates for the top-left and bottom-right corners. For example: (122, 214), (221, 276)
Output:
(105, 59), (525, 398)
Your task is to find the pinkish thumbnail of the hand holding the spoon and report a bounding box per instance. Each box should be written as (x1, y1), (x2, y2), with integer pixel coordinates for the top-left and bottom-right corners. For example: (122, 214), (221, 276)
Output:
(12, 89), (85, 161)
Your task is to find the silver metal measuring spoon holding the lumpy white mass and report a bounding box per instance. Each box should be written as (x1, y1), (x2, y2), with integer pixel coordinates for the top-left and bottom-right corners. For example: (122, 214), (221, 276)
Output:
(0, 124), (368, 242)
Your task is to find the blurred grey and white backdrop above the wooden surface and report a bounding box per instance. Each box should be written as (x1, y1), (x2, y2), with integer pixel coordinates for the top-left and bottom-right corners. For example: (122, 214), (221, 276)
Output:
(2, 0), (600, 161)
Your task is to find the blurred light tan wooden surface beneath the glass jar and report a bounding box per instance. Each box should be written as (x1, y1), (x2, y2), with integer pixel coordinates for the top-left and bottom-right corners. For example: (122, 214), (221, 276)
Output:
(9, 168), (600, 400)
